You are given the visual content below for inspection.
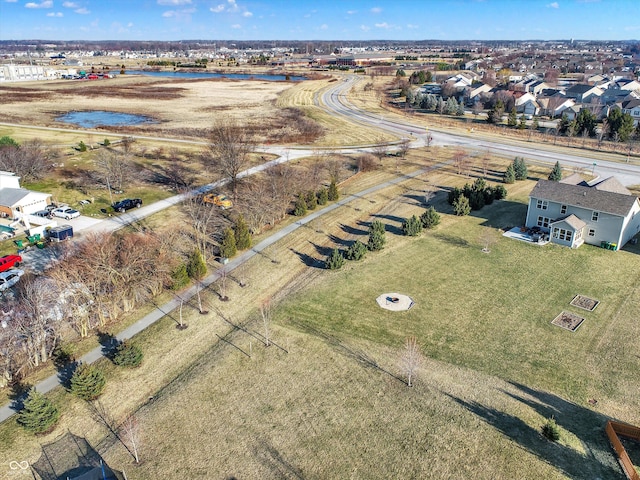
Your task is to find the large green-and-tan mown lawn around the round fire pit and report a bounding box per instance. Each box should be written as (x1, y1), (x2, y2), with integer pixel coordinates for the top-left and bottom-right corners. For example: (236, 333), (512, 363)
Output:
(0, 149), (640, 479)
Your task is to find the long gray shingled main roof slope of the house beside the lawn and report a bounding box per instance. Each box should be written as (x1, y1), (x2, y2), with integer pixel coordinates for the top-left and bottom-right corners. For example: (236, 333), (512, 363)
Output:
(530, 180), (638, 217)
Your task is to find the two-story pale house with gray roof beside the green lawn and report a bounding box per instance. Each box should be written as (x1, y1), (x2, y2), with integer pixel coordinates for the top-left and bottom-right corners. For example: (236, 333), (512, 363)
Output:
(525, 174), (640, 249)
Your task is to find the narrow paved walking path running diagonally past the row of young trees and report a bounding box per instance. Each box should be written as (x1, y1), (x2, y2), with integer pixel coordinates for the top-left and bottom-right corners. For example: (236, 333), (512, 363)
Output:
(0, 164), (442, 422)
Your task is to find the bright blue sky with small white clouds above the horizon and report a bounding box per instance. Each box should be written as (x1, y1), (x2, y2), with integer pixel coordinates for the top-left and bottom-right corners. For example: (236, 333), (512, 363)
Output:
(0, 0), (640, 41)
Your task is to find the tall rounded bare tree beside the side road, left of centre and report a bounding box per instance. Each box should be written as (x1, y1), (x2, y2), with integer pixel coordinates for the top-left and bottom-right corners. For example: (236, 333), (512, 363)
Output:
(209, 117), (253, 199)
